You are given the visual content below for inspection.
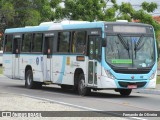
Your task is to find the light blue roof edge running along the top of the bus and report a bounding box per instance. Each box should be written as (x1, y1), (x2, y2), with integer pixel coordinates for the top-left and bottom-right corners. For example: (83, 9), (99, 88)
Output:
(5, 21), (151, 34)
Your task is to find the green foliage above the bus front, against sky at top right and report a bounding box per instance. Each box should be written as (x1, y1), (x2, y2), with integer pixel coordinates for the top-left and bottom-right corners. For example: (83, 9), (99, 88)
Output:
(117, 2), (160, 31)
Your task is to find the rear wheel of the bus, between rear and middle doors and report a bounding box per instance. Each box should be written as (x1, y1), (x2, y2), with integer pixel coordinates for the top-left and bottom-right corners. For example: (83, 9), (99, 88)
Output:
(25, 70), (35, 89)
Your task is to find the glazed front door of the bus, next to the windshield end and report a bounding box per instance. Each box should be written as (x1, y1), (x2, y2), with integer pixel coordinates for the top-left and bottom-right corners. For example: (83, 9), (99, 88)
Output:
(88, 36), (100, 86)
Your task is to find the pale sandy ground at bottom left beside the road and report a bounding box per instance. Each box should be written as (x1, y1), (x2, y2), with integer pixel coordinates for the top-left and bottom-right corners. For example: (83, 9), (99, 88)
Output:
(0, 91), (125, 120)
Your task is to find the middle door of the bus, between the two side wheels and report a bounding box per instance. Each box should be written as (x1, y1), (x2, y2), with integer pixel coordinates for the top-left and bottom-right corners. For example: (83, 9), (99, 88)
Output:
(42, 34), (54, 82)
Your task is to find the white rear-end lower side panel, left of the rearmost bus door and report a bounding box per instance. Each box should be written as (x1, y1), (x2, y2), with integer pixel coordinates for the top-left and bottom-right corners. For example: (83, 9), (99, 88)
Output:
(3, 54), (13, 78)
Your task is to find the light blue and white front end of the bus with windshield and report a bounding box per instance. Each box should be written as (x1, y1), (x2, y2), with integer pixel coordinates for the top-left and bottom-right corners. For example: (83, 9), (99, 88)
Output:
(101, 22), (157, 96)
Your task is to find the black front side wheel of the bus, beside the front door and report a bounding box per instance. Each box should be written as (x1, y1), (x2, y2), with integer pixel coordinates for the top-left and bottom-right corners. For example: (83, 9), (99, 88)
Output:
(78, 74), (91, 96)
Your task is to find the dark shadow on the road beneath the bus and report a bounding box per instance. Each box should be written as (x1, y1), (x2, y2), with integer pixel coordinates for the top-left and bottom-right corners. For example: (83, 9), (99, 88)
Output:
(7, 85), (145, 99)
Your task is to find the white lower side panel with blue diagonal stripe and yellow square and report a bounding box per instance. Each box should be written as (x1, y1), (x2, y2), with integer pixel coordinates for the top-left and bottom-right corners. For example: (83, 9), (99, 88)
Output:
(52, 55), (87, 85)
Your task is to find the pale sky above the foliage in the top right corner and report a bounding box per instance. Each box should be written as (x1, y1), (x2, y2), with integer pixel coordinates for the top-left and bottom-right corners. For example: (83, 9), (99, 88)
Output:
(110, 0), (160, 16)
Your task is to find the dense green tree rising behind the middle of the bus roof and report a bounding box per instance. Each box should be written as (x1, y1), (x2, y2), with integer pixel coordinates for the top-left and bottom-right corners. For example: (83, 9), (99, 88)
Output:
(61, 0), (105, 21)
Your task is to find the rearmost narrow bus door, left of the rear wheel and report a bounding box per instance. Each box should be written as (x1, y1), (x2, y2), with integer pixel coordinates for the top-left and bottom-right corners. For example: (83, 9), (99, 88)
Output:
(12, 35), (22, 78)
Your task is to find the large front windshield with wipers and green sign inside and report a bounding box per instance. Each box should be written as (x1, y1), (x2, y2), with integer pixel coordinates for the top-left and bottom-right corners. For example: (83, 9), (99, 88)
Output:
(106, 34), (155, 68)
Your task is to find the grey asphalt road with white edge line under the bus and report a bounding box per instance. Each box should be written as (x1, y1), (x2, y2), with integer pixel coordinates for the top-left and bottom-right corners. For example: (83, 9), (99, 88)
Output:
(0, 76), (160, 119)
